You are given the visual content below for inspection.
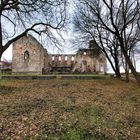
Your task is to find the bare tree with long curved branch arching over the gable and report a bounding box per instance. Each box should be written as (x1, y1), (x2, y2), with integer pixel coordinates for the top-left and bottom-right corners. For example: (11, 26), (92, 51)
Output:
(0, 0), (67, 59)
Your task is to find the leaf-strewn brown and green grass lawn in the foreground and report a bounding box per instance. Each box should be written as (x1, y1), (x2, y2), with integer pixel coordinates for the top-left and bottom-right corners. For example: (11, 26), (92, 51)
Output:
(0, 79), (140, 140)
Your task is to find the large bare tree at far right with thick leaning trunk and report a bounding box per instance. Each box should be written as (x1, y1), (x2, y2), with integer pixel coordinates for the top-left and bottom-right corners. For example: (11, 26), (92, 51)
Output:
(73, 0), (140, 83)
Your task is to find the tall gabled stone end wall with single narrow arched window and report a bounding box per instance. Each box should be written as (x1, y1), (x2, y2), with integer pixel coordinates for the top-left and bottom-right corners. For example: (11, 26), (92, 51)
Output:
(12, 35), (44, 74)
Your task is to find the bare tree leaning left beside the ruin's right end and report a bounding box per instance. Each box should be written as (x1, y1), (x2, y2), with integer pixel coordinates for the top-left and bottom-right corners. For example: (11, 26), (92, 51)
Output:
(73, 0), (121, 78)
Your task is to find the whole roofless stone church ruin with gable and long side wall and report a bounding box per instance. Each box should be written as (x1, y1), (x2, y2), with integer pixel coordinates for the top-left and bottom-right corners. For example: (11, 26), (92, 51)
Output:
(12, 35), (107, 74)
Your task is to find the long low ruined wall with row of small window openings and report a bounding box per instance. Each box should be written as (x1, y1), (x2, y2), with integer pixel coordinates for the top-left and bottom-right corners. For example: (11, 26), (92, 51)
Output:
(47, 54), (106, 73)
